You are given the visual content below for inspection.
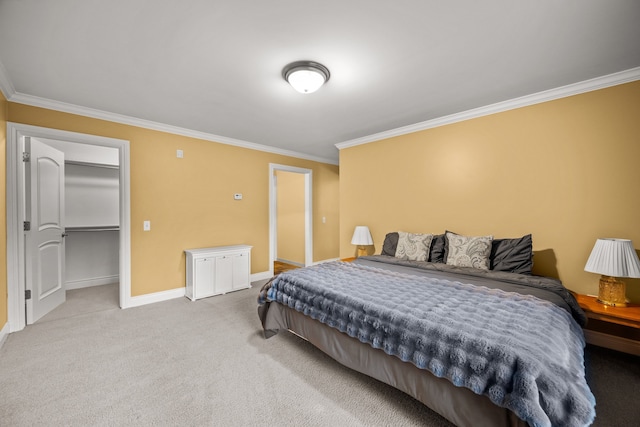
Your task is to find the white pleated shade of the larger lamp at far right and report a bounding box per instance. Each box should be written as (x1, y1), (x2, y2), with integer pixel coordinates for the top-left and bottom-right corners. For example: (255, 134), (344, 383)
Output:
(584, 239), (640, 278)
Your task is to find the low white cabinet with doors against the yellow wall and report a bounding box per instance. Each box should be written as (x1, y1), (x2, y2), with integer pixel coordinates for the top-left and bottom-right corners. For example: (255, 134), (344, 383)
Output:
(185, 245), (251, 301)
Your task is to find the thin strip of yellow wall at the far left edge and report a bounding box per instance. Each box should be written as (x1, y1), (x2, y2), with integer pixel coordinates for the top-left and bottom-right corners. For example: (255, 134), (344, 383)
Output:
(0, 92), (9, 329)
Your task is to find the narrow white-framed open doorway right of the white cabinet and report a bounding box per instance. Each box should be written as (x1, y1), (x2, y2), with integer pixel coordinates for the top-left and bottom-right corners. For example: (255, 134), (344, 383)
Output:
(269, 164), (313, 275)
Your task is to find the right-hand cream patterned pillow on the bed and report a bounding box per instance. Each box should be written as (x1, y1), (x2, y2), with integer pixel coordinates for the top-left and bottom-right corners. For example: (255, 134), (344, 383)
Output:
(446, 231), (493, 270)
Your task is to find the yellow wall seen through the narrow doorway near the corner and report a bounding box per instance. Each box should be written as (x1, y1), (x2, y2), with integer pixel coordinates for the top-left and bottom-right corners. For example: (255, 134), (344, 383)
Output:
(276, 171), (305, 265)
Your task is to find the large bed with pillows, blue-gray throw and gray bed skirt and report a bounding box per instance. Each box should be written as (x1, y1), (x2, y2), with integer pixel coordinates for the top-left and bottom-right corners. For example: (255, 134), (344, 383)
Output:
(258, 232), (595, 427)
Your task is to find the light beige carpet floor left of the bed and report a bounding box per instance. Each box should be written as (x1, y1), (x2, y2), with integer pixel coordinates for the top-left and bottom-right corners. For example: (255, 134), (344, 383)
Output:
(0, 284), (450, 426)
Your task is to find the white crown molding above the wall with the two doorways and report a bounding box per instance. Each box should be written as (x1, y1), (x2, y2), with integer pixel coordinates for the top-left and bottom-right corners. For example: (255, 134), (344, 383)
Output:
(6, 92), (338, 165)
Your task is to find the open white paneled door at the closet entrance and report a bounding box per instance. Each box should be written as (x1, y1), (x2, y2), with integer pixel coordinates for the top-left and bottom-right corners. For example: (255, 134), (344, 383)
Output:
(25, 138), (65, 324)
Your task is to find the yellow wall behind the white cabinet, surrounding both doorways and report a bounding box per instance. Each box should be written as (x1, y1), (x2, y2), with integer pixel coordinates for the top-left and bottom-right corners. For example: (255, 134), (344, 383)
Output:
(6, 102), (339, 298)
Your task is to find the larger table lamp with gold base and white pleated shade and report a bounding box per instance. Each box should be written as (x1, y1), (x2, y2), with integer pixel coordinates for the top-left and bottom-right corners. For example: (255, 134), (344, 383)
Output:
(584, 239), (640, 307)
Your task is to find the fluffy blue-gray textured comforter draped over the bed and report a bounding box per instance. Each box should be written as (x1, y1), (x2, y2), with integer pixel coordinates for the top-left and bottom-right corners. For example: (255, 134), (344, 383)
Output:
(260, 262), (595, 426)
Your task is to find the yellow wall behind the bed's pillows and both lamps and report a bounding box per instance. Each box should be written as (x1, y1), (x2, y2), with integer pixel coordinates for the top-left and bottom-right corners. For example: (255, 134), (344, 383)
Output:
(340, 82), (640, 302)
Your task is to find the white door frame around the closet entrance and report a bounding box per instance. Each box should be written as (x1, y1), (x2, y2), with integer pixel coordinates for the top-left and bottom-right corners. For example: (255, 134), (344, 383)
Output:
(7, 123), (131, 332)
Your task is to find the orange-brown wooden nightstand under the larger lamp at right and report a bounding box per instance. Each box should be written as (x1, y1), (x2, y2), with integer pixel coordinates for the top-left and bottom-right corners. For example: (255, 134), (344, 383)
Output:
(574, 294), (640, 356)
